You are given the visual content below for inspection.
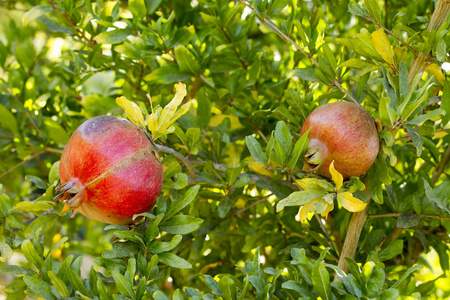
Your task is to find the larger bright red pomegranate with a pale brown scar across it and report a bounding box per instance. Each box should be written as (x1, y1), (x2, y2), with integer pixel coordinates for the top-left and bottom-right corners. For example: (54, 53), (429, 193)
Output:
(57, 116), (163, 224)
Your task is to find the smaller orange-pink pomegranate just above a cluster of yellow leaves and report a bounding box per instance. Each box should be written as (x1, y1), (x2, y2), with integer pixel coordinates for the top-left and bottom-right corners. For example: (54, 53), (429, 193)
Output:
(301, 101), (379, 178)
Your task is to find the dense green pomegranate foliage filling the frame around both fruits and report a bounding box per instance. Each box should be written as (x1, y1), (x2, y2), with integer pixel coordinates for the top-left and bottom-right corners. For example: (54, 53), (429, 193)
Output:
(0, 0), (450, 300)
